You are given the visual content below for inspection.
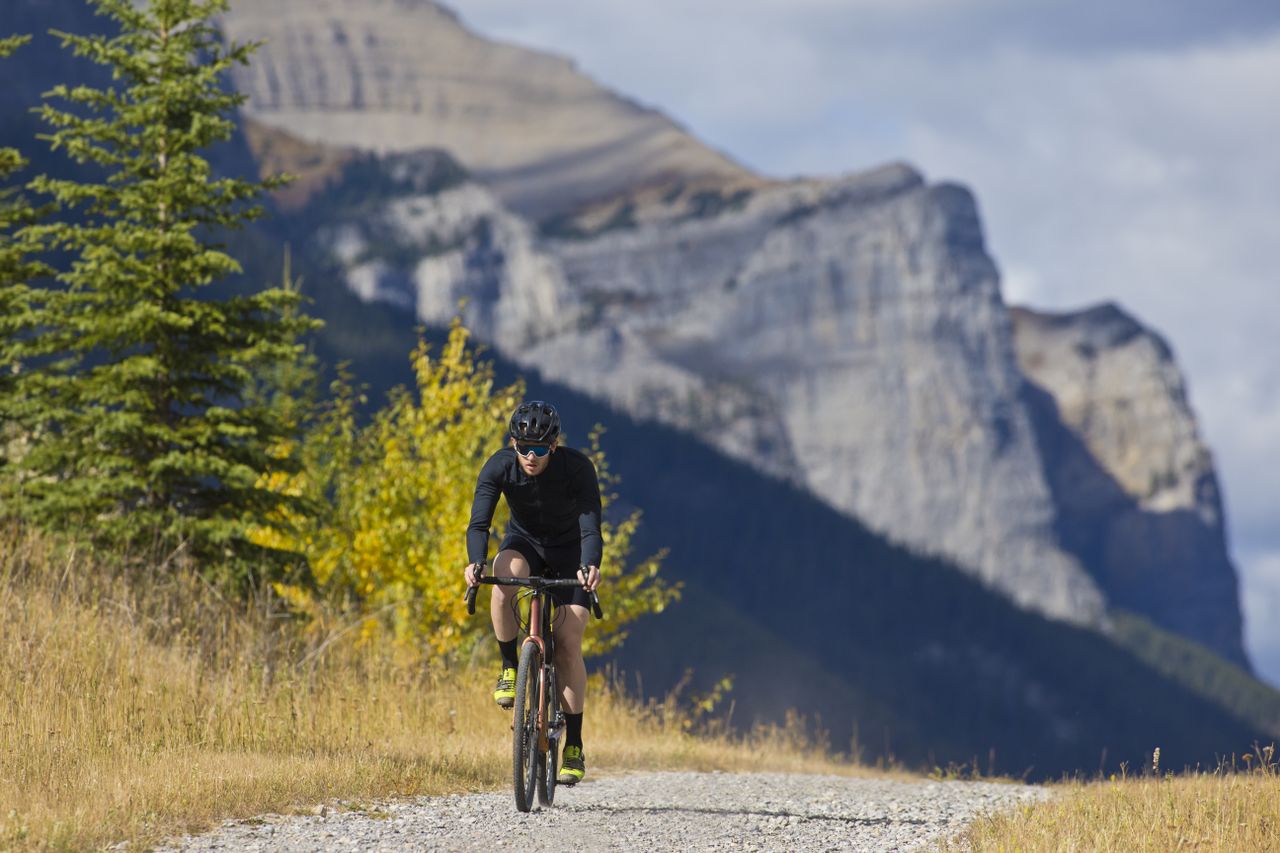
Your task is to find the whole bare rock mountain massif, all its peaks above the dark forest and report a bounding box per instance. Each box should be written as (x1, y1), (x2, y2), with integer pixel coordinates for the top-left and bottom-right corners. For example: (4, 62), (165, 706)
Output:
(207, 0), (1245, 663)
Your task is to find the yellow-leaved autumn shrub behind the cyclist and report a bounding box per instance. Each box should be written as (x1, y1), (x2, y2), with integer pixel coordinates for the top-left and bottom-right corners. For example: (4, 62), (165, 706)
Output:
(255, 321), (678, 657)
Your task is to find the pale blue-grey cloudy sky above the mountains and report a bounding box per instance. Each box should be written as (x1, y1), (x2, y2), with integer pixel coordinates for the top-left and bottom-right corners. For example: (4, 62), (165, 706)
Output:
(445, 0), (1280, 685)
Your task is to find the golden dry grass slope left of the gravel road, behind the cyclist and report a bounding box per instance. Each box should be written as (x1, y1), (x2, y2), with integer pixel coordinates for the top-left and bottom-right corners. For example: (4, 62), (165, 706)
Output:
(0, 532), (869, 849)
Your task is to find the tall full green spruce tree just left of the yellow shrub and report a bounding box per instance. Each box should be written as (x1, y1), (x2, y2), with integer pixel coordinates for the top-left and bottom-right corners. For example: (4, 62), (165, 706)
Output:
(9, 0), (315, 578)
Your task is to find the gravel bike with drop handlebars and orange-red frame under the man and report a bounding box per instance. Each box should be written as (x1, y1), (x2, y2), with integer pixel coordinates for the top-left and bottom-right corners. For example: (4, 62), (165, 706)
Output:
(466, 565), (604, 812)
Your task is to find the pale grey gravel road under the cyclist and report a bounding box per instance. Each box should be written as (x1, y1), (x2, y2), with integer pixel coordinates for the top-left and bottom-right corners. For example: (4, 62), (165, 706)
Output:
(154, 772), (1048, 853)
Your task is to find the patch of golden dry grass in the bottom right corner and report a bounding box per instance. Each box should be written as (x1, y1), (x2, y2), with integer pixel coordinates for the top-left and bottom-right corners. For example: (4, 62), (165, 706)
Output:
(941, 747), (1280, 853)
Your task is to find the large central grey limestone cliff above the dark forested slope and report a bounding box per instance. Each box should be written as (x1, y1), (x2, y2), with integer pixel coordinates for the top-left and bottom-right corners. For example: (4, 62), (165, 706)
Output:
(321, 154), (1103, 624)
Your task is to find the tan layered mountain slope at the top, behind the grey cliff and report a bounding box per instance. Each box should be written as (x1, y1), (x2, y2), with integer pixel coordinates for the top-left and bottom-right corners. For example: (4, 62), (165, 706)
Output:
(223, 0), (750, 215)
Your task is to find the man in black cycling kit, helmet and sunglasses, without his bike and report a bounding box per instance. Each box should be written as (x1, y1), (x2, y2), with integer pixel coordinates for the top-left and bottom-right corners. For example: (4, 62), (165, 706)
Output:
(463, 401), (604, 785)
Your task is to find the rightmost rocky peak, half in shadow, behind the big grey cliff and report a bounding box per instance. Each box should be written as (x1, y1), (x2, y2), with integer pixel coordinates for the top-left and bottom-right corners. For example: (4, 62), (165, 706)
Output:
(1012, 305), (1248, 666)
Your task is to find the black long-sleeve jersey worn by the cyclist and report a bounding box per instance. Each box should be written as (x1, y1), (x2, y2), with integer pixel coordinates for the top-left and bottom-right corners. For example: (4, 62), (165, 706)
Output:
(467, 447), (604, 566)
